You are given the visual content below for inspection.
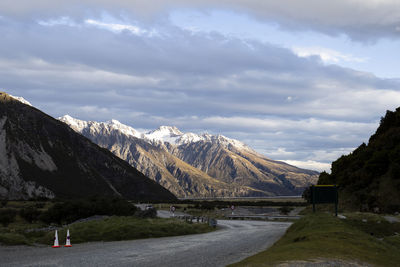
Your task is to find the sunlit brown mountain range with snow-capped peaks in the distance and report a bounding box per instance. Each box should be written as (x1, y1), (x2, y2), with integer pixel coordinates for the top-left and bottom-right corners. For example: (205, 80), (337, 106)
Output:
(59, 115), (318, 197)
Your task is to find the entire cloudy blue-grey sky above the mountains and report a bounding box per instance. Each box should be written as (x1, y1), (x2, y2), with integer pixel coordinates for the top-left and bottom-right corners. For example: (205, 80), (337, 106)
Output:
(0, 0), (400, 172)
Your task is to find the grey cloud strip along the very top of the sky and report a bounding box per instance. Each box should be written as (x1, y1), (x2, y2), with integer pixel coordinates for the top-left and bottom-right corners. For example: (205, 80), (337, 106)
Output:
(0, 0), (400, 42)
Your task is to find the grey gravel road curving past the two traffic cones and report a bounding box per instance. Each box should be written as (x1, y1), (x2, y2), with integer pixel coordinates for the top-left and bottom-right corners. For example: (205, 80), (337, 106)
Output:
(0, 220), (290, 267)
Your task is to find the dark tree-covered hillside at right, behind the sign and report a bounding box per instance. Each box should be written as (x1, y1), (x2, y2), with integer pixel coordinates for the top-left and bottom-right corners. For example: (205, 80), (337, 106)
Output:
(318, 108), (400, 212)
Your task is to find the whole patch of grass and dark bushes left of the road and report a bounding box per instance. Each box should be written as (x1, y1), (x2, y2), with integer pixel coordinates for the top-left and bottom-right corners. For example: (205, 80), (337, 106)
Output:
(0, 198), (214, 245)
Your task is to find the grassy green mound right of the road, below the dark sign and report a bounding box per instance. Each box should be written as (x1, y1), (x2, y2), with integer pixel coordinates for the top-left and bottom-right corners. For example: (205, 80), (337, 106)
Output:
(232, 212), (400, 266)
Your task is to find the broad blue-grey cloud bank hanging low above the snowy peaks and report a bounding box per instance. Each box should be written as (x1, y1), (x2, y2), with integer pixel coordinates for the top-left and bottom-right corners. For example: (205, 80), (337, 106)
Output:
(0, 13), (400, 172)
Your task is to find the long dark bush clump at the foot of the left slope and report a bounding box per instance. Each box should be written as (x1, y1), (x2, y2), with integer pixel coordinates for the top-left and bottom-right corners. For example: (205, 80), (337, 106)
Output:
(40, 198), (137, 224)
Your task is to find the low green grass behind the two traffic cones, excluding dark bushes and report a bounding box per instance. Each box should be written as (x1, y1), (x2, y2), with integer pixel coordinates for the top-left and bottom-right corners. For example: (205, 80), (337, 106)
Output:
(0, 201), (214, 245)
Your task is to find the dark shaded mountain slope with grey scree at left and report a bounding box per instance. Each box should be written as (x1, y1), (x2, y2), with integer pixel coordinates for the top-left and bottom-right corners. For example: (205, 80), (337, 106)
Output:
(0, 93), (175, 201)
